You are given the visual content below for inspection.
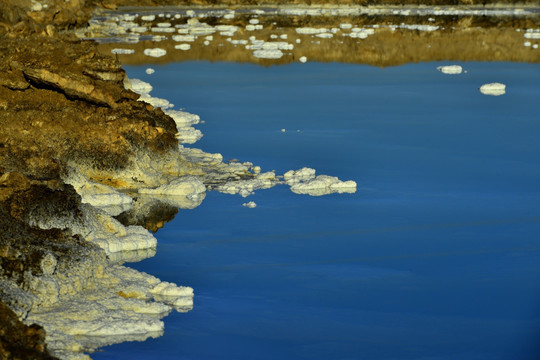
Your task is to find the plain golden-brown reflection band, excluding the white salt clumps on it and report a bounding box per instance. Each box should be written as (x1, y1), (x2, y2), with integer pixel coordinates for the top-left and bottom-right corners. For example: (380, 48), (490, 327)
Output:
(92, 9), (540, 67)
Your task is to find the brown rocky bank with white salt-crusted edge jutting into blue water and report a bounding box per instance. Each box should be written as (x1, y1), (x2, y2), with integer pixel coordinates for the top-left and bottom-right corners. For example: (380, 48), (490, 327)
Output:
(0, 0), (535, 359)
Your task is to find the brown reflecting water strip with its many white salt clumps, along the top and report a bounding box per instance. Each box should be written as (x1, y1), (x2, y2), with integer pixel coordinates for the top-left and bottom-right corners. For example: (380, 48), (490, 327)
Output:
(79, 7), (540, 66)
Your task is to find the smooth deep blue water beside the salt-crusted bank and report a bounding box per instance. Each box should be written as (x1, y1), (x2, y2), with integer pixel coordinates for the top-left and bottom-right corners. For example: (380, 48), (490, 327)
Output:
(93, 62), (540, 360)
